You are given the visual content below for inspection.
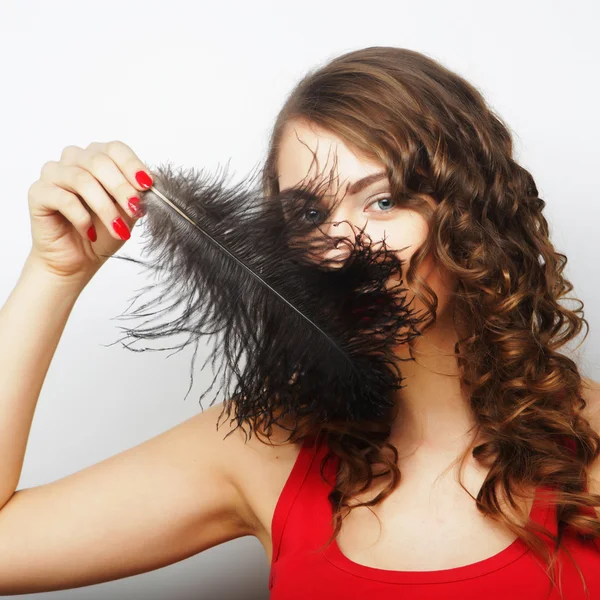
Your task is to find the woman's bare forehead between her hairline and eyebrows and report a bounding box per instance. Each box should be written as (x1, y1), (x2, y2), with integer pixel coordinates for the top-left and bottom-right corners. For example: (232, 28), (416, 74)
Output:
(277, 120), (386, 193)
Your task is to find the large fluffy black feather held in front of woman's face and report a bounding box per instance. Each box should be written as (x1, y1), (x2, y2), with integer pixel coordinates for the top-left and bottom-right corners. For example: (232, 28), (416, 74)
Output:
(108, 163), (421, 438)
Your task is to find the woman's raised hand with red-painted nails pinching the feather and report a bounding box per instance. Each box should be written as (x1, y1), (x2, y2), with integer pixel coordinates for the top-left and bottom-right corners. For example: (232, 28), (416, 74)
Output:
(28, 141), (152, 282)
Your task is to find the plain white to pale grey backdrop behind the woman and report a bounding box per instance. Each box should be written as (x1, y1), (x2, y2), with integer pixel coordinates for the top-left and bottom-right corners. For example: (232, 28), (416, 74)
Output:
(0, 0), (600, 600)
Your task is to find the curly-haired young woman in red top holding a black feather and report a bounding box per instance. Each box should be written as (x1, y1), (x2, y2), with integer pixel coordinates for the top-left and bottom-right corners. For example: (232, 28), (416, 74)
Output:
(0, 47), (600, 600)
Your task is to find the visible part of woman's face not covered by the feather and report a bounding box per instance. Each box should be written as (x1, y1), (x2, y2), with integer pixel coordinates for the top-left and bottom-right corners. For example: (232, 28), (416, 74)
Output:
(277, 120), (460, 332)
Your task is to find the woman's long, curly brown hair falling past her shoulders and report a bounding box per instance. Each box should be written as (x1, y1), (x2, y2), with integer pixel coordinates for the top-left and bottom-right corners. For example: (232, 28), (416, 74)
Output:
(251, 47), (600, 595)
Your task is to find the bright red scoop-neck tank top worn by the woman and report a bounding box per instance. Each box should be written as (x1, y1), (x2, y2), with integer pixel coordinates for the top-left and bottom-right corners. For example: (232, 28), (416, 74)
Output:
(269, 440), (600, 600)
